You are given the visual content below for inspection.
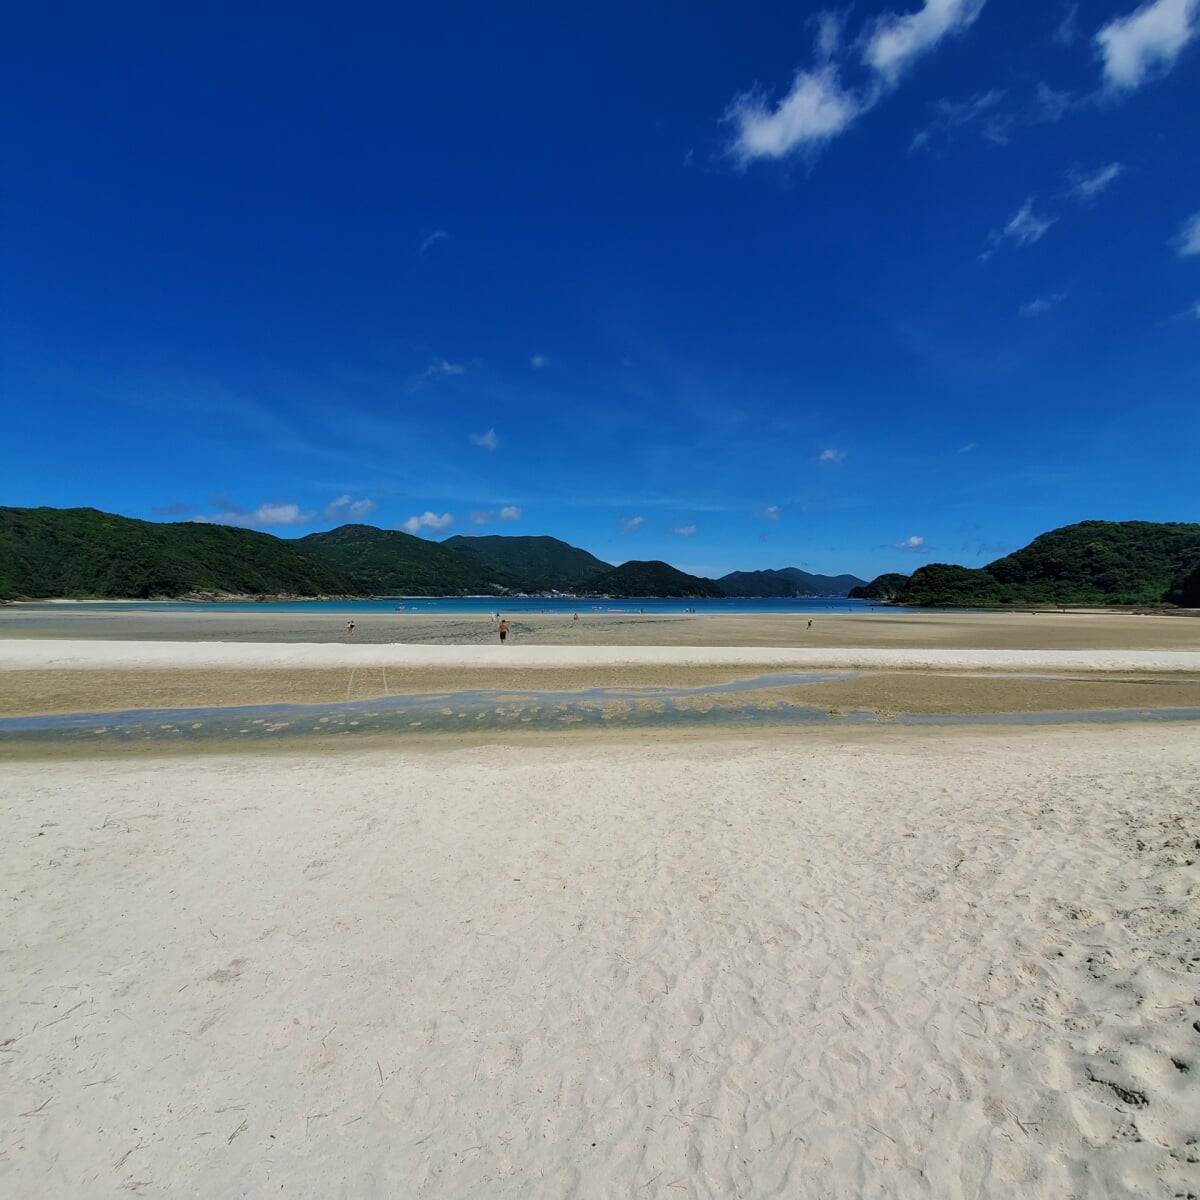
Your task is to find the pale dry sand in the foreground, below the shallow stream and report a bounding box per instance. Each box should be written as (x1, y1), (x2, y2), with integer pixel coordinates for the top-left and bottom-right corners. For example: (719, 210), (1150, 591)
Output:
(0, 726), (1200, 1200)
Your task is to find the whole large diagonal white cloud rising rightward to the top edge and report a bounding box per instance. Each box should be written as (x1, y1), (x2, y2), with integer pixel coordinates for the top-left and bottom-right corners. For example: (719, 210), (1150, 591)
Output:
(724, 0), (985, 166)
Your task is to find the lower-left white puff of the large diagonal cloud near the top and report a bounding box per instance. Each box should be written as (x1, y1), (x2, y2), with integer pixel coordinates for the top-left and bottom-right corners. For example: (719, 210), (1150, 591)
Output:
(725, 66), (864, 164)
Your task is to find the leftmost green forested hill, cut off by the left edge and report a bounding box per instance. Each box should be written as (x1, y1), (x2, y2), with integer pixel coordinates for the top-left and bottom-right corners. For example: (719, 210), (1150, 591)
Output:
(0, 508), (354, 600)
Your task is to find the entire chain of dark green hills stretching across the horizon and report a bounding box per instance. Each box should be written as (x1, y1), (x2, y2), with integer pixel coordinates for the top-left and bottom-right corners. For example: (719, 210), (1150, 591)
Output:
(0, 508), (1200, 607)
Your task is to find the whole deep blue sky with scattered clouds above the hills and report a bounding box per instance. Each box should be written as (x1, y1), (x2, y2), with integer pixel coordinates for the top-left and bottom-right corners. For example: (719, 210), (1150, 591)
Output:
(0, 0), (1200, 578)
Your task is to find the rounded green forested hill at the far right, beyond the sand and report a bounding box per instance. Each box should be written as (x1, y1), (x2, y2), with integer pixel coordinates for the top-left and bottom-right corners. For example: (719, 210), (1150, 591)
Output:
(896, 521), (1200, 606)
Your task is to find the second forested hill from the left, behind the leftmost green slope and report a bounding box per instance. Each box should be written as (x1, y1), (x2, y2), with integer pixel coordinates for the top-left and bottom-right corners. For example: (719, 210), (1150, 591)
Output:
(295, 524), (528, 595)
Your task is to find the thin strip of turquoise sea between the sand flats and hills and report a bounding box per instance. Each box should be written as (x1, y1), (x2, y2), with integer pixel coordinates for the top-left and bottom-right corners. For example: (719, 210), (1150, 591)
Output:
(37, 596), (902, 618)
